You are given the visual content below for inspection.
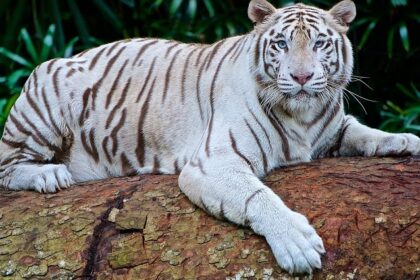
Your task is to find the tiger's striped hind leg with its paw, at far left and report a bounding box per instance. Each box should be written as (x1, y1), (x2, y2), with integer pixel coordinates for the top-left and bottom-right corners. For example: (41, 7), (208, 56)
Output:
(0, 77), (73, 192)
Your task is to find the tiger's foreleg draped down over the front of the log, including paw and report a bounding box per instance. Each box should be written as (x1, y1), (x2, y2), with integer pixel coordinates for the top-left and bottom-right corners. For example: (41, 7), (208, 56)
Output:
(179, 154), (325, 273)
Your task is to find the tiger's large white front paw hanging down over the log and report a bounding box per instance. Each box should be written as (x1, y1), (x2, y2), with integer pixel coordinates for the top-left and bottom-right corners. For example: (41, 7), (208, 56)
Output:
(265, 210), (325, 274)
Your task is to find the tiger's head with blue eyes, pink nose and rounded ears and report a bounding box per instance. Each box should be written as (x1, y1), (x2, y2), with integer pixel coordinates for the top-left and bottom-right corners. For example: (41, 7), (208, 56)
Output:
(248, 0), (356, 111)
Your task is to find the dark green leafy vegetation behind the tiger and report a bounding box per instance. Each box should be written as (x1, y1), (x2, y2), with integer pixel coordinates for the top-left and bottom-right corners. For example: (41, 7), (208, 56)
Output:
(0, 0), (420, 135)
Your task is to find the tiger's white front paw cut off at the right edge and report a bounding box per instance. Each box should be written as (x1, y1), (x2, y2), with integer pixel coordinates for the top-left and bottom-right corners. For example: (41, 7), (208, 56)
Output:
(368, 133), (420, 156)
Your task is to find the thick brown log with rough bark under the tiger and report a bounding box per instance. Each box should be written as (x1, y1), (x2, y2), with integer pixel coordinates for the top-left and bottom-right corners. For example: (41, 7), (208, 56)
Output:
(0, 157), (420, 280)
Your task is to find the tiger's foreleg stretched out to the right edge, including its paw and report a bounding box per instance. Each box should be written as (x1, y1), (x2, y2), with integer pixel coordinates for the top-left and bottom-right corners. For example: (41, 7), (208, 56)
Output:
(335, 116), (420, 156)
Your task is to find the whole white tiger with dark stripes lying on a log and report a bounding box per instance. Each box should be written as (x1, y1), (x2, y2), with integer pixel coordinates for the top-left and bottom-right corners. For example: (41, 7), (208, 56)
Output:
(0, 0), (420, 273)
